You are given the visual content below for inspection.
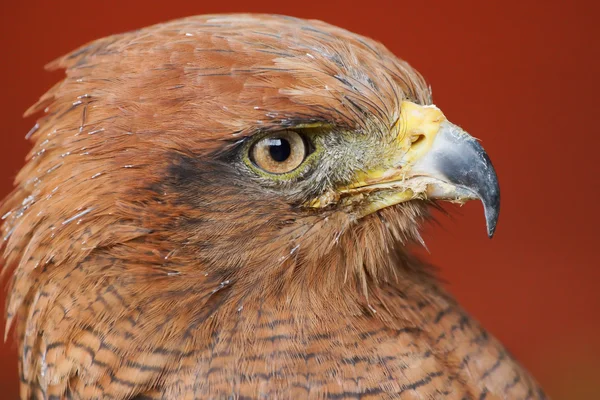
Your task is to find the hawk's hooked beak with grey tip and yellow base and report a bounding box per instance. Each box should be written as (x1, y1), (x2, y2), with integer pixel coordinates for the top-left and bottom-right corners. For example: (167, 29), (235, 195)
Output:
(316, 101), (500, 237)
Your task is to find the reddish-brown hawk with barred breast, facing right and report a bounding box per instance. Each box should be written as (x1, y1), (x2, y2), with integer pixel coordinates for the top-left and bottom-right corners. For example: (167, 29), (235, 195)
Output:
(0, 14), (544, 399)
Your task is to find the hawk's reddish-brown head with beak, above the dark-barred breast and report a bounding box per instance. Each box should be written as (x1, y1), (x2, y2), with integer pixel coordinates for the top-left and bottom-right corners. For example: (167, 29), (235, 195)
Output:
(3, 15), (500, 329)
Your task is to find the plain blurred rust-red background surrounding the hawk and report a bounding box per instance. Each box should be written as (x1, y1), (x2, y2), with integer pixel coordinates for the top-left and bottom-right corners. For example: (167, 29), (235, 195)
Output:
(0, 0), (600, 400)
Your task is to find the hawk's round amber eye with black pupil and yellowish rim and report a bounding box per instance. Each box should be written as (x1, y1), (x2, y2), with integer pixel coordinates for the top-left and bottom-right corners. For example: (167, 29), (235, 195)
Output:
(250, 130), (308, 174)
